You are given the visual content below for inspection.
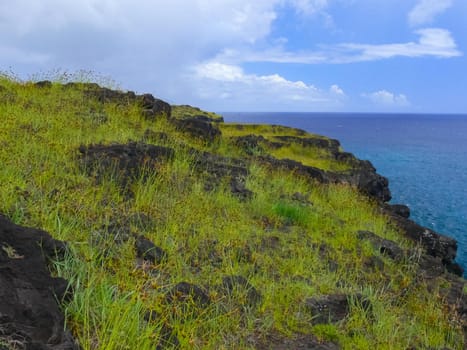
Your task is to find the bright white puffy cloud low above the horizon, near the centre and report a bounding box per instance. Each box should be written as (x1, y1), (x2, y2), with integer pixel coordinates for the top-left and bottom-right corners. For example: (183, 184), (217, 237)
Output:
(192, 62), (345, 111)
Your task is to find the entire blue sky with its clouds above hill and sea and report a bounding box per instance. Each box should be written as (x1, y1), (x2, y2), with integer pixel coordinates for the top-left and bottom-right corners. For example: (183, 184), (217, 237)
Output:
(0, 0), (467, 113)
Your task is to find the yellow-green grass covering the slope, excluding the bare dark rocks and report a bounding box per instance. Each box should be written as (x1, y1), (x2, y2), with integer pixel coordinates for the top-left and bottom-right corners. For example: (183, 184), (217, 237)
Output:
(0, 77), (463, 350)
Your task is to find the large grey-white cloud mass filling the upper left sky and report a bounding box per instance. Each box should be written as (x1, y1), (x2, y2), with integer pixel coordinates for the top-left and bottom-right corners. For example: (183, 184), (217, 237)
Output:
(0, 0), (279, 88)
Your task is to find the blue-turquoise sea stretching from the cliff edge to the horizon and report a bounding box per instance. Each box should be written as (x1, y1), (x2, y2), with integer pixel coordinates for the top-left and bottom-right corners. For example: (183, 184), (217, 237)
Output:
(222, 113), (467, 269)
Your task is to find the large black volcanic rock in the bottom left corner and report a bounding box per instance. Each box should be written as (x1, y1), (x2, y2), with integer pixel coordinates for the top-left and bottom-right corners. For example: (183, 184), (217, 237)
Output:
(0, 215), (79, 350)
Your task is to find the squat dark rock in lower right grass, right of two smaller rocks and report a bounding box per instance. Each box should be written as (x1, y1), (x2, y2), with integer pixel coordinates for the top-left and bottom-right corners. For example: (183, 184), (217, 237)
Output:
(306, 294), (371, 324)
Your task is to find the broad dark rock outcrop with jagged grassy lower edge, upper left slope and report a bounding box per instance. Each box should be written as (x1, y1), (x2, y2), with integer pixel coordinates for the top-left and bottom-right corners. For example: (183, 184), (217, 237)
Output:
(79, 142), (174, 185)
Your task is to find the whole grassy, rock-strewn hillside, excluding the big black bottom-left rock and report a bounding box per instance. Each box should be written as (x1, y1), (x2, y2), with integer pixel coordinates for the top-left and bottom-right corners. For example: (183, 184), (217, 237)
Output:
(0, 77), (466, 349)
